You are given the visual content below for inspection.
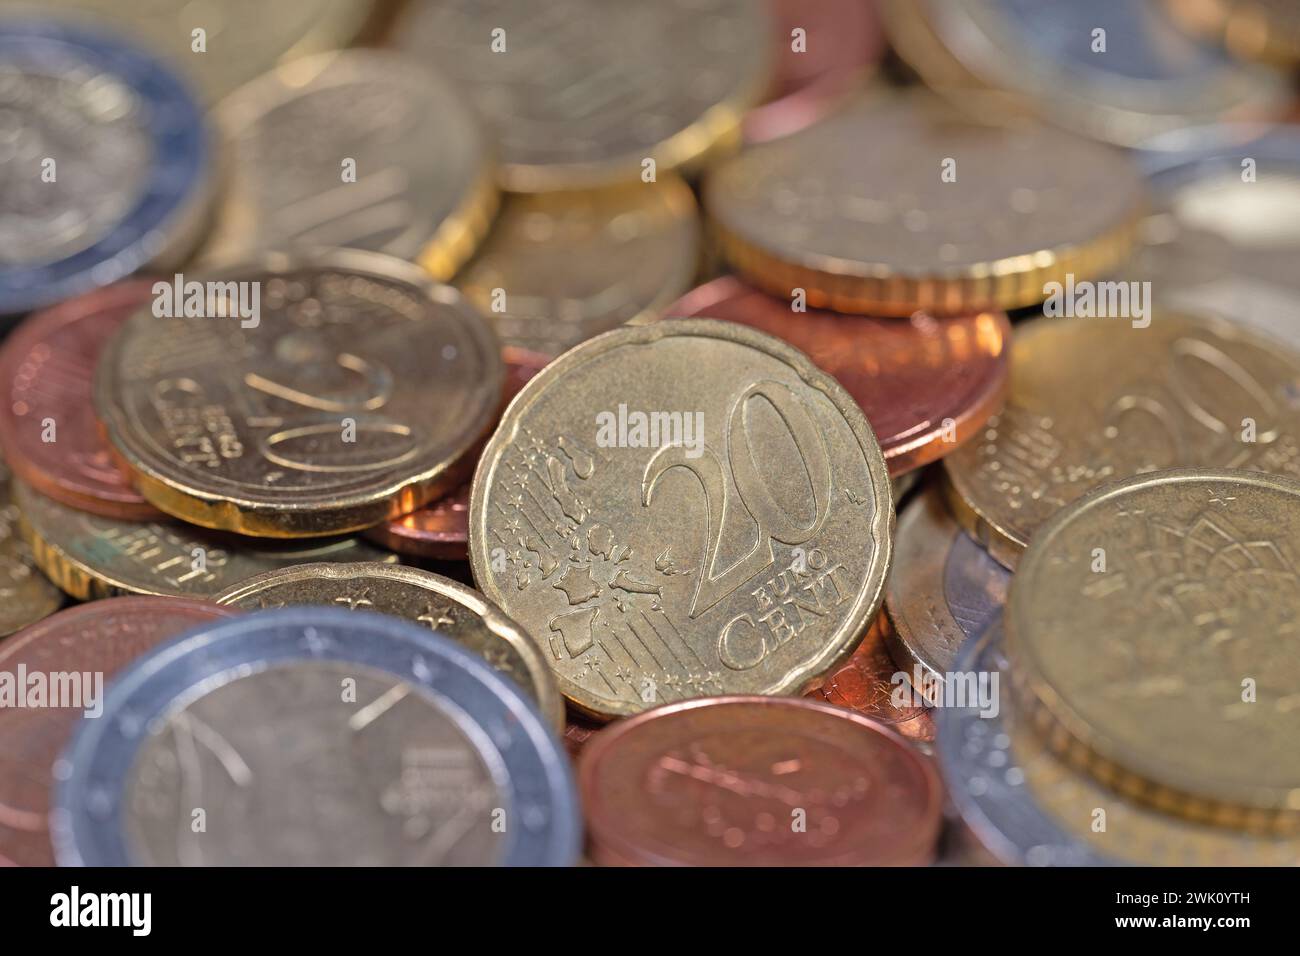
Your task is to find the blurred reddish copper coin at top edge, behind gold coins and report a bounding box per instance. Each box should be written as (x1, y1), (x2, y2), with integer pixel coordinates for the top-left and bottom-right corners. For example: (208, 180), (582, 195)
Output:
(741, 0), (885, 143)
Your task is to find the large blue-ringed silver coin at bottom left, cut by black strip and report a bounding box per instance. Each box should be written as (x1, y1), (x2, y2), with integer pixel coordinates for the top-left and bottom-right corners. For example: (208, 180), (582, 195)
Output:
(51, 607), (582, 866)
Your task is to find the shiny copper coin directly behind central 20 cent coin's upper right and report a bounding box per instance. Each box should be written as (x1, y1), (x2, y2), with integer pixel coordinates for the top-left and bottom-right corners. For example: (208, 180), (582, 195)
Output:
(667, 276), (1011, 475)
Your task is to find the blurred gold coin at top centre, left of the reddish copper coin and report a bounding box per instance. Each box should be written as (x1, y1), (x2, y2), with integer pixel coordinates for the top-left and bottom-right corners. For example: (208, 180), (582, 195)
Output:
(394, 0), (771, 193)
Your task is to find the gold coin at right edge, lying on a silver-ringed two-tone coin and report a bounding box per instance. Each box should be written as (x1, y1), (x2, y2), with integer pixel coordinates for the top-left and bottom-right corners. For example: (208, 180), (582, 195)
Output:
(1006, 468), (1300, 834)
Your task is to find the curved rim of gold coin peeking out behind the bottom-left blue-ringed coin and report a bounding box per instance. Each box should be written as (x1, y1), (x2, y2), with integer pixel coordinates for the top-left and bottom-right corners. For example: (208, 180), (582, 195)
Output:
(209, 561), (564, 734)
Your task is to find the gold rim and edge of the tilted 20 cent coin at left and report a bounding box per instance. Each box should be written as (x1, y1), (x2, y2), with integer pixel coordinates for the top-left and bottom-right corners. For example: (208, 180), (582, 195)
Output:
(95, 250), (506, 537)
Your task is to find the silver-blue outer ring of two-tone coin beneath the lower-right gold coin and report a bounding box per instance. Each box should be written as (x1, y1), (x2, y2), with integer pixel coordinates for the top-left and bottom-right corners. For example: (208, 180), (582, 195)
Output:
(935, 617), (1115, 866)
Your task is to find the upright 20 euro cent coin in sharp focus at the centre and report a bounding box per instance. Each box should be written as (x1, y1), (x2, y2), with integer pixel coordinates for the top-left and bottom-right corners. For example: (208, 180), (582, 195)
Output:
(469, 319), (893, 717)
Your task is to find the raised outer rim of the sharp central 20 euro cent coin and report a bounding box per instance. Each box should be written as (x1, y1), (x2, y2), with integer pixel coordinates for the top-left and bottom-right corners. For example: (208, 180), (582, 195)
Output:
(469, 319), (894, 721)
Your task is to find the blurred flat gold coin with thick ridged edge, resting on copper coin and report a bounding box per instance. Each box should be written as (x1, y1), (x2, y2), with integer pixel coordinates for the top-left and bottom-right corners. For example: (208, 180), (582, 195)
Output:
(703, 95), (1145, 316)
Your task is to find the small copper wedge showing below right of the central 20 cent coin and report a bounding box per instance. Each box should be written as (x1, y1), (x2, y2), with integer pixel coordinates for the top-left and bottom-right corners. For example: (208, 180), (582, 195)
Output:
(807, 614), (935, 744)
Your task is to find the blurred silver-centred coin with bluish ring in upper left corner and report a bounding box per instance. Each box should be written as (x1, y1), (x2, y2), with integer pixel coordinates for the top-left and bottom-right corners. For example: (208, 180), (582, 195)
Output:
(0, 20), (213, 315)
